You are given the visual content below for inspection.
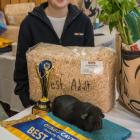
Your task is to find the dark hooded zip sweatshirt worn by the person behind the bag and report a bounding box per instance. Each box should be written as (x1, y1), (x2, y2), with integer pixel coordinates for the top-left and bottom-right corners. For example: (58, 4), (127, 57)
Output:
(14, 3), (94, 107)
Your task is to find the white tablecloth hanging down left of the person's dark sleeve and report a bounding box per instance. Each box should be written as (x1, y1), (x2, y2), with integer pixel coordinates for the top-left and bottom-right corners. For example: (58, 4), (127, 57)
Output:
(0, 52), (24, 112)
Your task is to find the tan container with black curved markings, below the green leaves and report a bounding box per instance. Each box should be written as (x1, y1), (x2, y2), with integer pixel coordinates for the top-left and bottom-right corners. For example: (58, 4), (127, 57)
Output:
(118, 49), (140, 117)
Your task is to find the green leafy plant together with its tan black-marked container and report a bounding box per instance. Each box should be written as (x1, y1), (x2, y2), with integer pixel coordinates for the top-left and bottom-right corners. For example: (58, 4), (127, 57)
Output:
(98, 0), (140, 116)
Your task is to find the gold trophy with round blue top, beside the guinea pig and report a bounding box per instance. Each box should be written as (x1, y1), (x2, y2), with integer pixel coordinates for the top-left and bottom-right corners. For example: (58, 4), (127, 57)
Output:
(32, 60), (52, 114)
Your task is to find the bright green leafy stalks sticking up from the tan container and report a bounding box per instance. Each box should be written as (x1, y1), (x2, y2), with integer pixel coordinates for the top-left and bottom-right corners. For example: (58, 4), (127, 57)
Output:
(98, 0), (140, 45)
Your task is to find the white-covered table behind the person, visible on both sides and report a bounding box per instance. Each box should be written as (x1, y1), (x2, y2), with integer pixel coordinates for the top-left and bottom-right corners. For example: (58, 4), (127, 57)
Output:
(0, 26), (115, 112)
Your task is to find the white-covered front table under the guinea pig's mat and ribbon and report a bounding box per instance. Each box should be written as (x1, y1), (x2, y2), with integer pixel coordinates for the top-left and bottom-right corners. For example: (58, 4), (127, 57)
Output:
(0, 103), (140, 140)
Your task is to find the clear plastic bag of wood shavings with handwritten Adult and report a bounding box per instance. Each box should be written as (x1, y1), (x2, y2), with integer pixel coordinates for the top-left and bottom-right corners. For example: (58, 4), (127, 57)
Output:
(27, 43), (116, 112)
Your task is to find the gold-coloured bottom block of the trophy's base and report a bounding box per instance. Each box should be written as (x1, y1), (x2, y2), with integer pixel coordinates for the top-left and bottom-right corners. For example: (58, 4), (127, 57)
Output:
(32, 105), (48, 115)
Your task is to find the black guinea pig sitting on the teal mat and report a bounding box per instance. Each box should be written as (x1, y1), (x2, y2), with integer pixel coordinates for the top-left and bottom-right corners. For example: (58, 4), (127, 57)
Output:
(52, 95), (104, 132)
